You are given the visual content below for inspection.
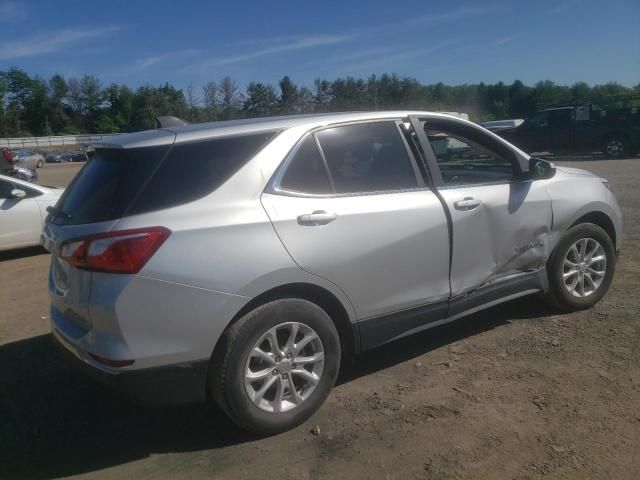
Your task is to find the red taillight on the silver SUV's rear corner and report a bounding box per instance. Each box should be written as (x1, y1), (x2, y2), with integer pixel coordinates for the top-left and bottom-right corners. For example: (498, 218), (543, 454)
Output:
(60, 227), (171, 273)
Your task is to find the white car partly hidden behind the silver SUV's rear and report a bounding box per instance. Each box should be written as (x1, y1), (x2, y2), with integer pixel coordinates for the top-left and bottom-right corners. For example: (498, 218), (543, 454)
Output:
(0, 175), (64, 250)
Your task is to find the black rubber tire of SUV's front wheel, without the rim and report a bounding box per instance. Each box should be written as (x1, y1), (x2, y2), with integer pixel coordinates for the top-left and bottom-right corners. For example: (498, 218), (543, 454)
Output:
(543, 223), (616, 311)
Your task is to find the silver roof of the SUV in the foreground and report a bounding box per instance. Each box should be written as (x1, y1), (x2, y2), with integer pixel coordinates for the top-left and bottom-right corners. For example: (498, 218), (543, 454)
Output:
(92, 110), (472, 148)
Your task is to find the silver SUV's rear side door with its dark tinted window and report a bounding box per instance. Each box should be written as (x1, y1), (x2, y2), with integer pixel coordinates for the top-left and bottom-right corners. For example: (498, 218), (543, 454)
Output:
(262, 121), (449, 344)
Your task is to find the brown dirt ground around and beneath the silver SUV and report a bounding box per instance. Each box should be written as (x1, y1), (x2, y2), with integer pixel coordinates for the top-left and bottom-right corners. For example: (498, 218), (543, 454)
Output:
(0, 158), (640, 480)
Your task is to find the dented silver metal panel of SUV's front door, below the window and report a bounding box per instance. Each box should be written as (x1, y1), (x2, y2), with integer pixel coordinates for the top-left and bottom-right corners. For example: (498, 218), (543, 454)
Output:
(440, 181), (553, 296)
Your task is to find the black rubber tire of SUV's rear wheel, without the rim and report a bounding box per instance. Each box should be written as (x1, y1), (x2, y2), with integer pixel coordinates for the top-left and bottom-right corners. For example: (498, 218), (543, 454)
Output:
(208, 298), (341, 435)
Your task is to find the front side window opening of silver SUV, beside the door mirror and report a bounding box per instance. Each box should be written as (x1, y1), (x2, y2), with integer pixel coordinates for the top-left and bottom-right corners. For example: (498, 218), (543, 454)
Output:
(426, 129), (514, 185)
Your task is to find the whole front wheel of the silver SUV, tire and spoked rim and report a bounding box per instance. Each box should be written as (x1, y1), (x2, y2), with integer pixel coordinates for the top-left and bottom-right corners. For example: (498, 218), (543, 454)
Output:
(547, 223), (616, 311)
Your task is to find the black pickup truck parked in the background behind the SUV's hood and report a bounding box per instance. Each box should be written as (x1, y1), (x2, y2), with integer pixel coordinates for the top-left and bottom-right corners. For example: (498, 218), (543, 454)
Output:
(495, 105), (640, 158)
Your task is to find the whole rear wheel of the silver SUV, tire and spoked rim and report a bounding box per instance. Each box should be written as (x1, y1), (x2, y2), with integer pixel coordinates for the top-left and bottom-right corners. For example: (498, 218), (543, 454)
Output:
(209, 299), (340, 434)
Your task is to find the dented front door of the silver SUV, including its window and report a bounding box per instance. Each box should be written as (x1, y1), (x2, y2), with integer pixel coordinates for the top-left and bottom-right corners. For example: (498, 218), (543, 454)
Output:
(414, 119), (552, 315)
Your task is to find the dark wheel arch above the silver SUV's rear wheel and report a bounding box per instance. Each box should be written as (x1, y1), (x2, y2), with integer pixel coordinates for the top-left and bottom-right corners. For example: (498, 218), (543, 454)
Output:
(214, 283), (360, 365)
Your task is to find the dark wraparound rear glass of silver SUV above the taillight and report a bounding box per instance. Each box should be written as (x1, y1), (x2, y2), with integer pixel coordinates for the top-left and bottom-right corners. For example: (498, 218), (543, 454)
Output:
(56, 132), (275, 225)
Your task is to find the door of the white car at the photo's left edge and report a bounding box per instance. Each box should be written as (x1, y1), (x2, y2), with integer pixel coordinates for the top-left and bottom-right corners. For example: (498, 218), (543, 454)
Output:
(0, 179), (42, 248)
